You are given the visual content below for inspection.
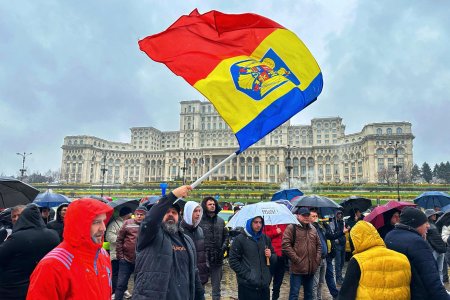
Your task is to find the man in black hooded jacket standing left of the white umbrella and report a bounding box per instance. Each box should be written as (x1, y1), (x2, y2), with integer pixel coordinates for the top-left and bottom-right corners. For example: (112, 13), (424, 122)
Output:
(199, 196), (228, 300)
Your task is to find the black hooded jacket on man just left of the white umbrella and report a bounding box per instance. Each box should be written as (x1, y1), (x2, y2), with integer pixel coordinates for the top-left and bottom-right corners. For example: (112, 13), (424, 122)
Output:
(199, 199), (228, 265)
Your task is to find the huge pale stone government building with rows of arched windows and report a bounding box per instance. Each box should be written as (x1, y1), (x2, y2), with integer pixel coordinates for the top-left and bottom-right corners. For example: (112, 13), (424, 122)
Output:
(61, 100), (414, 184)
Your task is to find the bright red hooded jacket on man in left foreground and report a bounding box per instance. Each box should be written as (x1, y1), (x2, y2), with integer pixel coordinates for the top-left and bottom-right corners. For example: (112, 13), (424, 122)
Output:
(27, 199), (113, 300)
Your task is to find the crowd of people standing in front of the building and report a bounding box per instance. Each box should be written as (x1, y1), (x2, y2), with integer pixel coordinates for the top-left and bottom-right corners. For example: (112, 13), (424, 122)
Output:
(0, 185), (450, 300)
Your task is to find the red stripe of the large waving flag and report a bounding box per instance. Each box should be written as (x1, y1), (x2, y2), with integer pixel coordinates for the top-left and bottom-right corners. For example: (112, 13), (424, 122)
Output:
(139, 10), (284, 85)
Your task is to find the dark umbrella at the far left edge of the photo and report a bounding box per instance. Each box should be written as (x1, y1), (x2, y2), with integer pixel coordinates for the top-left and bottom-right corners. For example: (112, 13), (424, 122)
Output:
(0, 177), (39, 208)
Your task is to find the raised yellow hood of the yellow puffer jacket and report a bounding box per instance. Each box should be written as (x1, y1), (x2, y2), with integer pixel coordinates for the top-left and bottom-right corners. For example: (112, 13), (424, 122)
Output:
(350, 221), (386, 254)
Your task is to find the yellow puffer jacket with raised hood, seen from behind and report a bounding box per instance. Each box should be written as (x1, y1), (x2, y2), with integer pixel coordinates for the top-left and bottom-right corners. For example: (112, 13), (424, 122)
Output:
(350, 221), (411, 300)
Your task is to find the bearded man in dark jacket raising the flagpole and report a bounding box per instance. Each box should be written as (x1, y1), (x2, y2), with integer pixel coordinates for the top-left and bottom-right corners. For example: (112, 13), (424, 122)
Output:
(133, 185), (204, 300)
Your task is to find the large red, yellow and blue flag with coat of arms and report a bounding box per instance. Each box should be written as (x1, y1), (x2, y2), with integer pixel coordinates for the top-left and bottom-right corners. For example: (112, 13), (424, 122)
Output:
(139, 10), (323, 153)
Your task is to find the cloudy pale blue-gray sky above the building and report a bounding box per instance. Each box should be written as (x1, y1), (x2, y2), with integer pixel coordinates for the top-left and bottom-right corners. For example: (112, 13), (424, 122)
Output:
(0, 0), (450, 175)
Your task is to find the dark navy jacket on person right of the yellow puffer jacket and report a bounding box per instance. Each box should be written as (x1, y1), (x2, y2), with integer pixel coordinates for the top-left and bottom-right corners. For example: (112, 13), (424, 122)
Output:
(384, 223), (450, 300)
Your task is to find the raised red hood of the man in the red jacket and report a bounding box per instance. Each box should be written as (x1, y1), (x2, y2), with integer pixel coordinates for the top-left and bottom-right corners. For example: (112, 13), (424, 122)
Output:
(64, 198), (113, 251)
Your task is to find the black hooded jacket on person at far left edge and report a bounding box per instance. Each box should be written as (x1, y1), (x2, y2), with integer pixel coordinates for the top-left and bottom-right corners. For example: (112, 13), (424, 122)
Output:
(0, 204), (59, 300)
